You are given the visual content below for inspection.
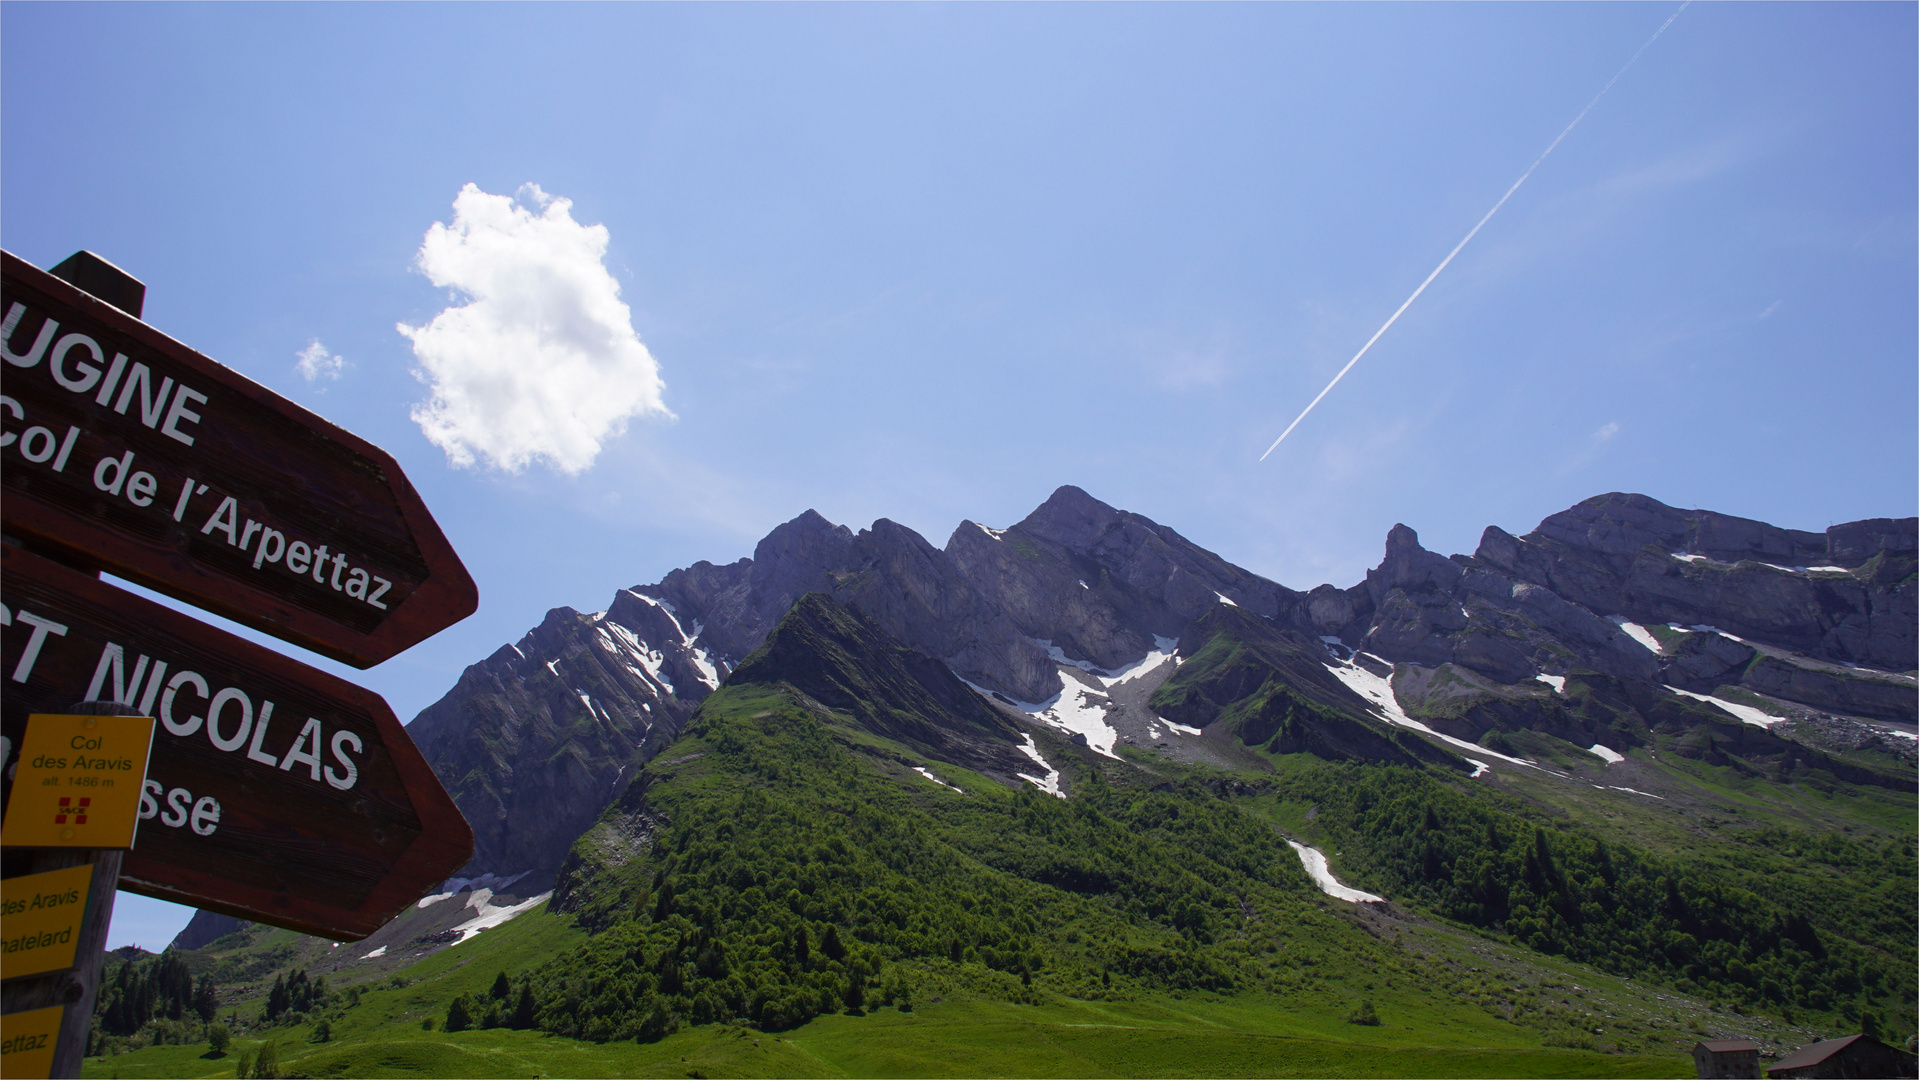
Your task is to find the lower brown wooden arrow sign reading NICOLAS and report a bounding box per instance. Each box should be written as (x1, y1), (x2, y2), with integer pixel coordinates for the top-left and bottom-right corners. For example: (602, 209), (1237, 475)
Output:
(0, 548), (474, 940)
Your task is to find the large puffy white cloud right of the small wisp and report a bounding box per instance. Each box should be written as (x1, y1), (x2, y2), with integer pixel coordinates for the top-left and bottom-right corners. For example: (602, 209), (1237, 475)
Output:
(399, 184), (672, 474)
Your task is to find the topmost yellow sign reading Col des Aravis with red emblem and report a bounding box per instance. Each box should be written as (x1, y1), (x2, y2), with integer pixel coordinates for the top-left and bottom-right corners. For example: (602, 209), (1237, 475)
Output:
(0, 714), (154, 848)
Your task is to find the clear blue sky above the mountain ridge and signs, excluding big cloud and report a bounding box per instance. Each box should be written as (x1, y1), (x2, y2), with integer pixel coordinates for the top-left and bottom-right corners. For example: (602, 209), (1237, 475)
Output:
(0, 0), (1919, 948)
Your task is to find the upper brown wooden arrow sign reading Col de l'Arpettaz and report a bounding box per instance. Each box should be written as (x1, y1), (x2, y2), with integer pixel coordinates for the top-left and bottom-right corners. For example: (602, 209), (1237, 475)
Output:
(0, 251), (480, 668)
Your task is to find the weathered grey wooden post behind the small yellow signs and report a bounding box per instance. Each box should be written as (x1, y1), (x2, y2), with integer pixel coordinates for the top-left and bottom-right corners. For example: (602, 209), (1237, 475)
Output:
(0, 702), (129, 1076)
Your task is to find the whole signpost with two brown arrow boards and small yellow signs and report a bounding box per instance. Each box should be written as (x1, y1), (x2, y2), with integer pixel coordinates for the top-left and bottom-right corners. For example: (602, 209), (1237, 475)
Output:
(0, 251), (478, 1076)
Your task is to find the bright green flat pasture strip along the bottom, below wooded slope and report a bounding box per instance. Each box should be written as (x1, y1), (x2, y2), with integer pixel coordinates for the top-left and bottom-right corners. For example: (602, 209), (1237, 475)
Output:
(83, 999), (1689, 1080)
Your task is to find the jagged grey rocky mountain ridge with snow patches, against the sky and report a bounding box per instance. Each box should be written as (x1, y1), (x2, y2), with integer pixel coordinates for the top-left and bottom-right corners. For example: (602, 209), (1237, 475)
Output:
(397, 487), (1919, 880)
